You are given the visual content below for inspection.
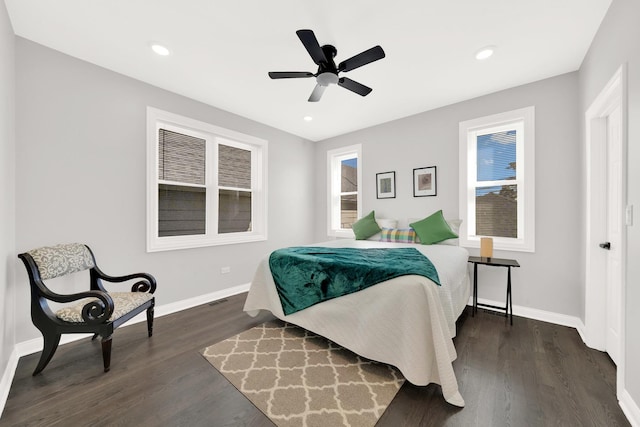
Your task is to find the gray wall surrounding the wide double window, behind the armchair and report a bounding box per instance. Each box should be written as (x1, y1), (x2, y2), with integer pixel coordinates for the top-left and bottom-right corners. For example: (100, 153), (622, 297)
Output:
(16, 38), (315, 342)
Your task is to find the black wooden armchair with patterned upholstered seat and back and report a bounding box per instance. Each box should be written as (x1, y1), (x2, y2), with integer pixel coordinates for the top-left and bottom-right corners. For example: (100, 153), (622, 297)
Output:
(18, 243), (156, 375)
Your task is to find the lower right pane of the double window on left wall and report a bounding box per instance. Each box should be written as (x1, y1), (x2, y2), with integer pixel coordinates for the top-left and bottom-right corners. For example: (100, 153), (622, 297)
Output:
(218, 190), (252, 234)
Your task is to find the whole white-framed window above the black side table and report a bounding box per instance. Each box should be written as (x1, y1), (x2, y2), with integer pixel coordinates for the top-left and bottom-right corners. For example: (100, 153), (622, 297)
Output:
(460, 107), (535, 252)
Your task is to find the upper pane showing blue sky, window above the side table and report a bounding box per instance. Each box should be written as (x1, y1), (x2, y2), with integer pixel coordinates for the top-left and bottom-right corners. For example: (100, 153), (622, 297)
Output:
(477, 130), (516, 181)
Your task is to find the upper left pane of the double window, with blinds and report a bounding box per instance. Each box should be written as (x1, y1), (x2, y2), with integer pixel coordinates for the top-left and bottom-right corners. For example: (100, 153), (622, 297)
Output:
(158, 129), (205, 185)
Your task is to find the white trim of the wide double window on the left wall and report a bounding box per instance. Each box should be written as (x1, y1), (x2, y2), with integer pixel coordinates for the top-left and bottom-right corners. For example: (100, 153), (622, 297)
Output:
(147, 107), (268, 252)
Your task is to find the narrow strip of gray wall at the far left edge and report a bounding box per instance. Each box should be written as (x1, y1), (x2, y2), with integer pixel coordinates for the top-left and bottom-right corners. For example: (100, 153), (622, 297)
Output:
(0, 2), (17, 377)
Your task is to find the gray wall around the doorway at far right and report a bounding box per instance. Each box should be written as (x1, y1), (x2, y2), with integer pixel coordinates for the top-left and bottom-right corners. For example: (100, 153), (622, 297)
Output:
(580, 0), (640, 412)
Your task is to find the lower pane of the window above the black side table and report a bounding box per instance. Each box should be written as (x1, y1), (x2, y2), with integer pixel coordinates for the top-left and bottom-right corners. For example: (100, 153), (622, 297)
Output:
(476, 185), (518, 238)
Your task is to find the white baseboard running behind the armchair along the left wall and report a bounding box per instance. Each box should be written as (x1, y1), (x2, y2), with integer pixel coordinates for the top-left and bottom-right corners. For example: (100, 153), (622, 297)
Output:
(0, 283), (250, 416)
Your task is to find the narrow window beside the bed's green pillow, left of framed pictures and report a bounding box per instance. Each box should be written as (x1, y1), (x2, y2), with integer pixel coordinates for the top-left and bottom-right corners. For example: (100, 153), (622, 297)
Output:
(327, 145), (362, 237)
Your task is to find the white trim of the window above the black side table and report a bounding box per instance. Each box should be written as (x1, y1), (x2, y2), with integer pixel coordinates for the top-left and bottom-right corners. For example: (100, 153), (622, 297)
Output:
(459, 106), (535, 252)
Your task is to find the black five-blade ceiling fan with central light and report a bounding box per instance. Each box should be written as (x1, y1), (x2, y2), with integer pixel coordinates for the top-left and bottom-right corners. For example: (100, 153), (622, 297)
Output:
(269, 30), (385, 102)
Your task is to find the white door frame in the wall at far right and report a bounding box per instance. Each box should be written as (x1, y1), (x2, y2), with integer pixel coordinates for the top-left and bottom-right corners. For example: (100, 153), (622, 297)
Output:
(583, 64), (627, 396)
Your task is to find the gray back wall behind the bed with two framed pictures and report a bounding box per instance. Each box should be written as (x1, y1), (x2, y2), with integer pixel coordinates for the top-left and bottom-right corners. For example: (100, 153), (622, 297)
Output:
(316, 72), (582, 316)
